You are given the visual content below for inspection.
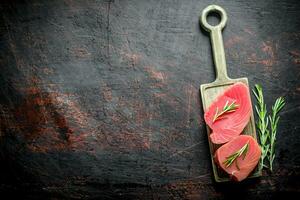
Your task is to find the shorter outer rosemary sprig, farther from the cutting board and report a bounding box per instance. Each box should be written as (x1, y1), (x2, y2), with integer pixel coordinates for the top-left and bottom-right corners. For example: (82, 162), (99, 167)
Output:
(269, 97), (285, 172)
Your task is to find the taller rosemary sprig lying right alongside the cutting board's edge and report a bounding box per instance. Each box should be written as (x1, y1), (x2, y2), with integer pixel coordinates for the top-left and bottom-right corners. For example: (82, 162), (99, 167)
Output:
(253, 84), (270, 170)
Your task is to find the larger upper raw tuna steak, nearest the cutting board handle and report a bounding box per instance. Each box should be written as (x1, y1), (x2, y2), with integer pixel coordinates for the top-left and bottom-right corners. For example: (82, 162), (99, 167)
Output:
(204, 82), (252, 144)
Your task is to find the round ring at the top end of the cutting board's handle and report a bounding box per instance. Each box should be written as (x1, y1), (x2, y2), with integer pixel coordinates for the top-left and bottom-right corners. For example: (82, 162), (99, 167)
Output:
(200, 5), (227, 32)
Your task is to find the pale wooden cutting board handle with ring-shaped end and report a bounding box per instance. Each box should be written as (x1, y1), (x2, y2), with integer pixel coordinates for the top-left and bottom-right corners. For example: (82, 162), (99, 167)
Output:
(200, 5), (230, 82)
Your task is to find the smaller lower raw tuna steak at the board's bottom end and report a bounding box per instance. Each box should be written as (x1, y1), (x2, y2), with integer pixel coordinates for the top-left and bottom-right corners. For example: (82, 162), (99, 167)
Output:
(215, 135), (261, 181)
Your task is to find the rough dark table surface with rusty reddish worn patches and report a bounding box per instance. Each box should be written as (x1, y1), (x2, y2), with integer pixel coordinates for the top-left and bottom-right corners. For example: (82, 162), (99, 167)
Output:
(0, 0), (300, 199)
